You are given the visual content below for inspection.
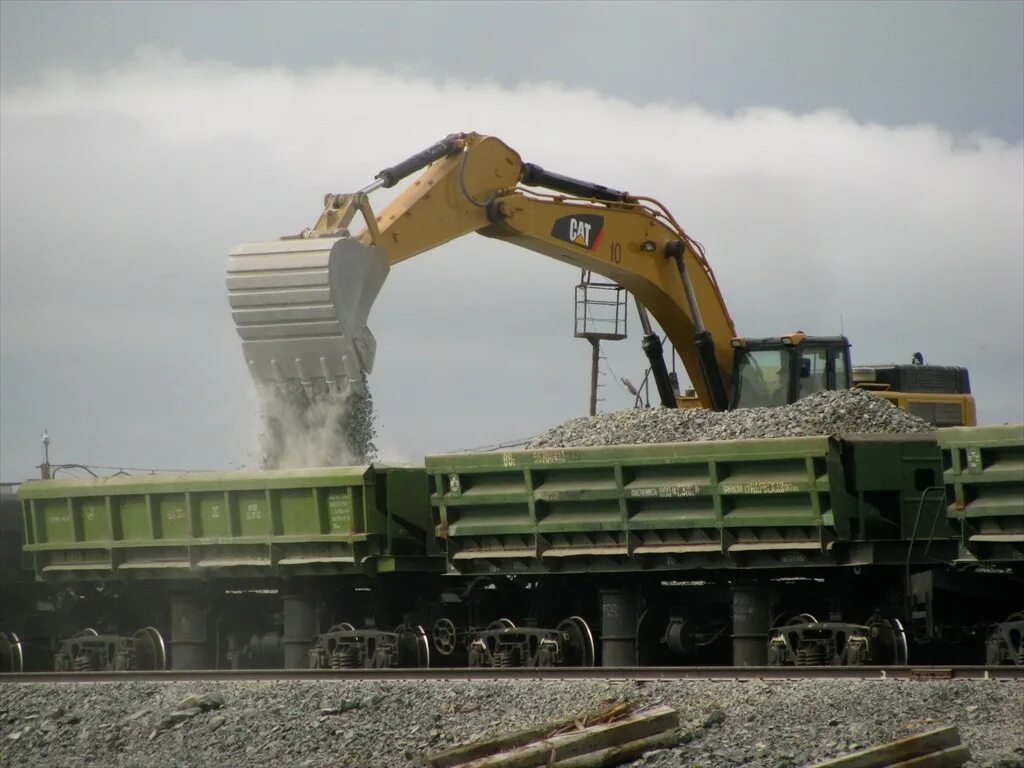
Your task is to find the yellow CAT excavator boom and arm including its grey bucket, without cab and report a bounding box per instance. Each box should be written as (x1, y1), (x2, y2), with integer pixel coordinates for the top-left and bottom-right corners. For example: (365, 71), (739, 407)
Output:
(228, 133), (736, 410)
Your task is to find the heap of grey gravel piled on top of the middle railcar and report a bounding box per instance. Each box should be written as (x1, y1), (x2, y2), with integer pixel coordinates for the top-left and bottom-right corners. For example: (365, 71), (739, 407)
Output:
(526, 389), (934, 450)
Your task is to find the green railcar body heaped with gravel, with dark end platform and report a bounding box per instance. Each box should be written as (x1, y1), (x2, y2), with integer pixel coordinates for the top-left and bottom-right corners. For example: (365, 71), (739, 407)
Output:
(426, 435), (951, 572)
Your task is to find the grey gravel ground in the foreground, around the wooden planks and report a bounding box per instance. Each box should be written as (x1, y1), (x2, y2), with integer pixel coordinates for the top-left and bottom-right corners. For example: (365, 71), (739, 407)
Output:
(0, 680), (1024, 768)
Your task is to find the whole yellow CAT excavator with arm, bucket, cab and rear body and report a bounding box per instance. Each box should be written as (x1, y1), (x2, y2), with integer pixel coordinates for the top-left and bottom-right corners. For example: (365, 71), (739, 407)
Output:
(227, 133), (976, 426)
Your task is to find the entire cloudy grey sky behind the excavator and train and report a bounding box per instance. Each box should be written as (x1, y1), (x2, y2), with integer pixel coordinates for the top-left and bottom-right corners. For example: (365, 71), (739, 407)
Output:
(0, 0), (1024, 480)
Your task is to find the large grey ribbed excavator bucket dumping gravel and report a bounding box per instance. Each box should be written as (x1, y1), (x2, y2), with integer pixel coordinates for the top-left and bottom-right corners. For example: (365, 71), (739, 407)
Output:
(227, 238), (389, 397)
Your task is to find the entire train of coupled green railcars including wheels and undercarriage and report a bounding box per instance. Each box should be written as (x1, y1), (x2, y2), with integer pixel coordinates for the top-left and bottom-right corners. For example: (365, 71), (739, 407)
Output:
(6, 434), (1024, 671)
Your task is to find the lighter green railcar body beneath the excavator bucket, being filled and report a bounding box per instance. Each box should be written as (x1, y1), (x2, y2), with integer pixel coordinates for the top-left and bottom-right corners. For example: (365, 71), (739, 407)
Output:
(18, 466), (439, 581)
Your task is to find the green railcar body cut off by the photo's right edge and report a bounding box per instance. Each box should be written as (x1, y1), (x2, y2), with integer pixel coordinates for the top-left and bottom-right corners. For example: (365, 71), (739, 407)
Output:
(938, 424), (1024, 563)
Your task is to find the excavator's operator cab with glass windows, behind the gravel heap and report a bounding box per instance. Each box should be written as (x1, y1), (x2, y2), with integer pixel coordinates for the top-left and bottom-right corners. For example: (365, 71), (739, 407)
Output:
(729, 333), (851, 409)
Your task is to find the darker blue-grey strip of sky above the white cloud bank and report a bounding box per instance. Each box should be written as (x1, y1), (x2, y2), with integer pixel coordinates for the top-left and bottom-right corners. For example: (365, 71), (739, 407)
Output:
(0, 0), (1024, 140)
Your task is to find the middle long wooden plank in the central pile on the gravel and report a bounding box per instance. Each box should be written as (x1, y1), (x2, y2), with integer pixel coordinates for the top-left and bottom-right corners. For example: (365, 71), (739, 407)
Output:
(464, 707), (679, 768)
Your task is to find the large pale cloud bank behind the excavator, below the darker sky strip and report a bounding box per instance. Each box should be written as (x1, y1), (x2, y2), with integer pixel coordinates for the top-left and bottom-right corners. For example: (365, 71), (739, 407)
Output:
(0, 57), (1024, 479)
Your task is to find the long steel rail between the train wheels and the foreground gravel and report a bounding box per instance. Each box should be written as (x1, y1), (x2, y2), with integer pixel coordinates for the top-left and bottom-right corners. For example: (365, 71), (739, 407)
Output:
(0, 666), (1024, 684)
